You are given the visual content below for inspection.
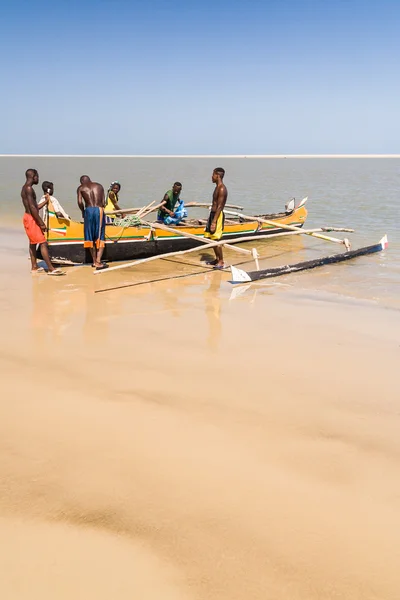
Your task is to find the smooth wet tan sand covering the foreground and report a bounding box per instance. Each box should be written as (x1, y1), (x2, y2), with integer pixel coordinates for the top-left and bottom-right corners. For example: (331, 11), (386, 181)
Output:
(0, 227), (400, 600)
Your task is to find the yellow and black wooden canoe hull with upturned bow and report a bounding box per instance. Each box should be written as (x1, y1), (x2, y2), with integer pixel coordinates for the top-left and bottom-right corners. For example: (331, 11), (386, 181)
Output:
(42, 198), (307, 263)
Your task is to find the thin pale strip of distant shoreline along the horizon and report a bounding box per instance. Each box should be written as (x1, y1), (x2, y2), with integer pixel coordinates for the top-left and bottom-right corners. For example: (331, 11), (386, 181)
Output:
(0, 154), (400, 159)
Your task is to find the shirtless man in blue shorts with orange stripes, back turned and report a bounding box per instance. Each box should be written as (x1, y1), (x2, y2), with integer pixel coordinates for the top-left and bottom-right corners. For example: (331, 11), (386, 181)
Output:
(77, 175), (108, 271)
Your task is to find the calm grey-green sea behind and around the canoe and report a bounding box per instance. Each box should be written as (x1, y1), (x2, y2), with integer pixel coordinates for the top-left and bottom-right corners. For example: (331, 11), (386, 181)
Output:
(0, 157), (400, 308)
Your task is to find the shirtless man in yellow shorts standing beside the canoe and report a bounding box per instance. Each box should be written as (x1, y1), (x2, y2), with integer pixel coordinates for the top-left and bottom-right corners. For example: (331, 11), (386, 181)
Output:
(204, 167), (228, 269)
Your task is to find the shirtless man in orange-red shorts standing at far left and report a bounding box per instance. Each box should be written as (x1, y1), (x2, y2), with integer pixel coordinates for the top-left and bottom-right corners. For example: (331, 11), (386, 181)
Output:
(21, 169), (65, 275)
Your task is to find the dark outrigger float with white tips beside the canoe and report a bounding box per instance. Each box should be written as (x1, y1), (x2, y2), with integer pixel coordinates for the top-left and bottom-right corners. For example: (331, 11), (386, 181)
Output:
(230, 235), (388, 283)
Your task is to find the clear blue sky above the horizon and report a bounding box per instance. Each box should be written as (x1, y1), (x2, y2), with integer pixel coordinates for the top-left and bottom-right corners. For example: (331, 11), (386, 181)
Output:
(0, 0), (400, 154)
